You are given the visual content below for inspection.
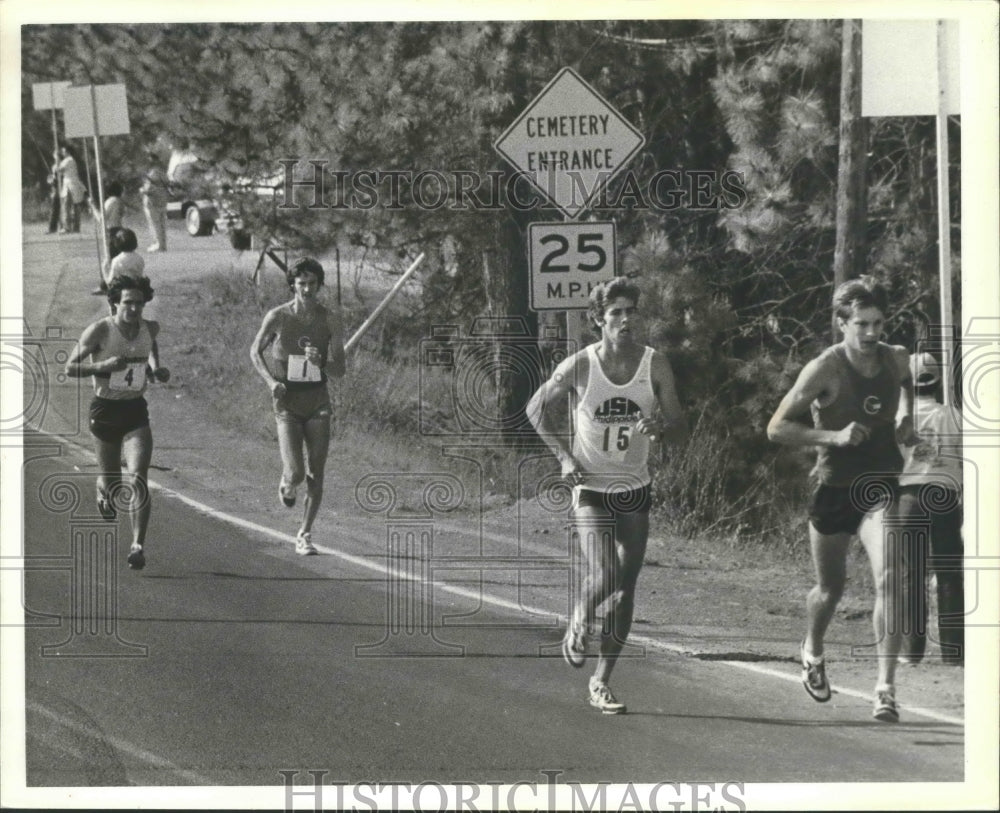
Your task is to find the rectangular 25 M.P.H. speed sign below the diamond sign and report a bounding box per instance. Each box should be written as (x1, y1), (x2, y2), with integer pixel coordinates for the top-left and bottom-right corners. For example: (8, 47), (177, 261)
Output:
(528, 223), (617, 311)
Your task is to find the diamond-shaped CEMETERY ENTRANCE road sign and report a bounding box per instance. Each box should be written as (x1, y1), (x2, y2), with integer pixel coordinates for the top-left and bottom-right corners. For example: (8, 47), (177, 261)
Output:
(493, 68), (646, 219)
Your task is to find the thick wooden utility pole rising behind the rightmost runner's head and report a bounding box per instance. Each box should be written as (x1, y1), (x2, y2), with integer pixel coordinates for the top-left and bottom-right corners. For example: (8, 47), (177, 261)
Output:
(832, 20), (868, 342)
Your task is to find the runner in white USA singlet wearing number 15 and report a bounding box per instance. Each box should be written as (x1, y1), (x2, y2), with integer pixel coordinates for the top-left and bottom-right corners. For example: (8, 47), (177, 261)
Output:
(527, 278), (687, 714)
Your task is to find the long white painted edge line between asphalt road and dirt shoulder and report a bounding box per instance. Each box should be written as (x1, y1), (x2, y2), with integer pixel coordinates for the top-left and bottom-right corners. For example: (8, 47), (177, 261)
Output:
(43, 428), (964, 726)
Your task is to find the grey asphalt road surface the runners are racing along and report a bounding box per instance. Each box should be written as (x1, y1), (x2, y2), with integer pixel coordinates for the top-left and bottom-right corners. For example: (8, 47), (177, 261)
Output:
(9, 222), (964, 792)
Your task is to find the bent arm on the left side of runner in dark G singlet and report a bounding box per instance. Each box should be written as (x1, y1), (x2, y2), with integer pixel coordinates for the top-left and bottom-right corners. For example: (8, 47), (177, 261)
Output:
(767, 359), (871, 446)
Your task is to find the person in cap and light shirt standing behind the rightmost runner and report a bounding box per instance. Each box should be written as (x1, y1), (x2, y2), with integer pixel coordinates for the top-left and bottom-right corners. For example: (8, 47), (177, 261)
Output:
(899, 353), (965, 665)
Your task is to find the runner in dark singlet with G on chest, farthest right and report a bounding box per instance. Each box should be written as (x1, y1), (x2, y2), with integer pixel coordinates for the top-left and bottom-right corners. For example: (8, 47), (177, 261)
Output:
(767, 276), (916, 722)
